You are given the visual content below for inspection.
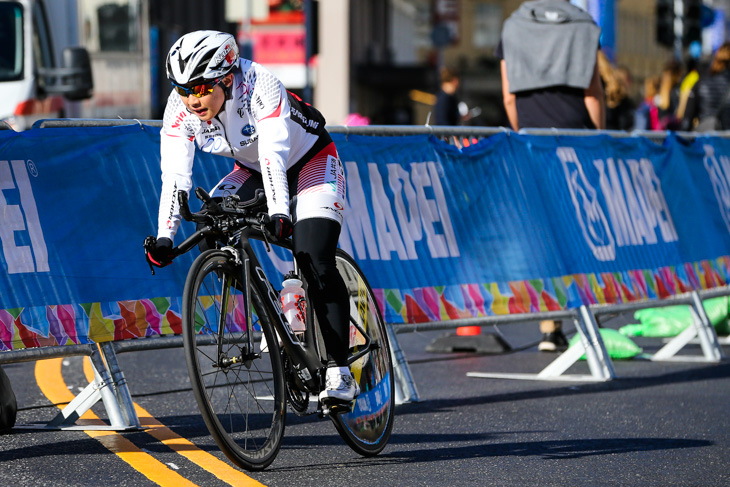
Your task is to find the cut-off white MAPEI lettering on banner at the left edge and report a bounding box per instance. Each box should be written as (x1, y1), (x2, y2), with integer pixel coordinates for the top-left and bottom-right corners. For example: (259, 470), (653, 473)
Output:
(0, 160), (50, 274)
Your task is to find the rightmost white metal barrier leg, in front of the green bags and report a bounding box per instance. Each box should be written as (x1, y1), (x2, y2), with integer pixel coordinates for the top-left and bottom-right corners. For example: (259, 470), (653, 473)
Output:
(651, 291), (724, 363)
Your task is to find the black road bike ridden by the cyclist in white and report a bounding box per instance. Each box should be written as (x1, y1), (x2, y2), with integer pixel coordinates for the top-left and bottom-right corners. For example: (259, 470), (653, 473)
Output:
(145, 188), (395, 470)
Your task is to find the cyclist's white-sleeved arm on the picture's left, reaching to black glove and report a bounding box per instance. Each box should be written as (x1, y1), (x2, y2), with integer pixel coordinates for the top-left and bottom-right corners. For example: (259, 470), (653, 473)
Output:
(157, 92), (196, 240)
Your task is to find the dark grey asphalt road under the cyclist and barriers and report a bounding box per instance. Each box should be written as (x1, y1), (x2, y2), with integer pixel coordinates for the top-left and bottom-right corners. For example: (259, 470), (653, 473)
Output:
(0, 316), (730, 487)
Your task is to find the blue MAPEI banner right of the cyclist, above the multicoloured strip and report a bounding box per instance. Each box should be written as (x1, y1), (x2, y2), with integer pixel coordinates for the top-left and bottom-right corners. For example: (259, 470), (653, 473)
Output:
(336, 134), (728, 288)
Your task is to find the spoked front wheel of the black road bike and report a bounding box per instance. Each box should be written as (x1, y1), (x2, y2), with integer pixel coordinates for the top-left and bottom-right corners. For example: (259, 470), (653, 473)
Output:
(182, 250), (286, 470)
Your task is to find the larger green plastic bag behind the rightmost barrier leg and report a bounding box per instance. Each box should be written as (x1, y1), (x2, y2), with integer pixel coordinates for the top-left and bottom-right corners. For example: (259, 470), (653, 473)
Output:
(619, 296), (730, 337)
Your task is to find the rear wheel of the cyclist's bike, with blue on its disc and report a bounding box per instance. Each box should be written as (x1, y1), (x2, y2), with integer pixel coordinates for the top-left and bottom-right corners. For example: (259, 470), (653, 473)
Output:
(330, 249), (395, 456)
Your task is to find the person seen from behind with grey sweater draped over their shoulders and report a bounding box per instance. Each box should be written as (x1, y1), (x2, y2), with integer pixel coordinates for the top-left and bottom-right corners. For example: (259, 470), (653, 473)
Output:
(495, 0), (606, 352)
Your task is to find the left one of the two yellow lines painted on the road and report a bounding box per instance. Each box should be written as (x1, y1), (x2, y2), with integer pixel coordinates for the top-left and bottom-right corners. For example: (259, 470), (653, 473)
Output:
(35, 358), (195, 487)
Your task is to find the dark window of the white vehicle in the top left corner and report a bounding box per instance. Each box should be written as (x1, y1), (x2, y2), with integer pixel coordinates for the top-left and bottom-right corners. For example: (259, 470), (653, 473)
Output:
(0, 2), (24, 81)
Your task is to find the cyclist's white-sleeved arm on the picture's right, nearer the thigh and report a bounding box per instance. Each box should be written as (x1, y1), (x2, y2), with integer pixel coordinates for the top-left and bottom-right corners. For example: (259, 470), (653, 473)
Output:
(251, 69), (291, 216)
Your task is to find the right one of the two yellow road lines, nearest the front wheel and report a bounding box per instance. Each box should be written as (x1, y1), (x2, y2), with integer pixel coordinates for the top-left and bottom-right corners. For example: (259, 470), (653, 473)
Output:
(84, 359), (264, 487)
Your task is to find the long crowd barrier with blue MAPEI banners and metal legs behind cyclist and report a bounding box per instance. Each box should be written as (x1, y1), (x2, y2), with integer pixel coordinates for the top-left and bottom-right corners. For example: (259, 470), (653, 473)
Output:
(0, 120), (730, 427)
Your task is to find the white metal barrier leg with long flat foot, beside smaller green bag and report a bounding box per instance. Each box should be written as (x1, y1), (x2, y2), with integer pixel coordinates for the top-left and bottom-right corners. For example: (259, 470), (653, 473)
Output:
(466, 306), (616, 382)
